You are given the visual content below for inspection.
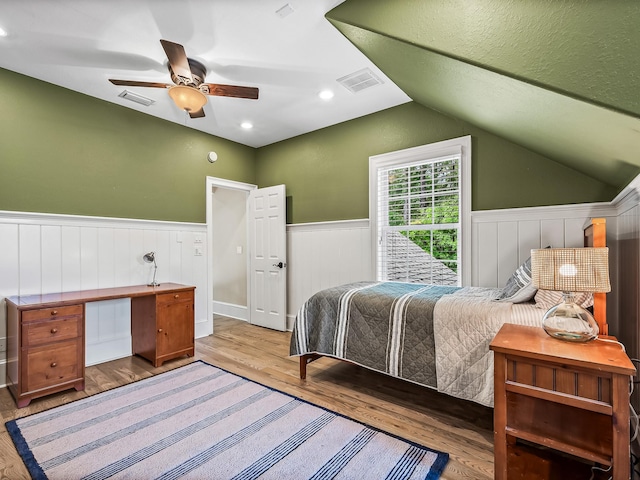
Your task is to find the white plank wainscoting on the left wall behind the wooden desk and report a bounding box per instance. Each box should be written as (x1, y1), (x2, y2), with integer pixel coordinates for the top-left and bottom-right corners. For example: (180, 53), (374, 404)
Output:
(0, 211), (212, 385)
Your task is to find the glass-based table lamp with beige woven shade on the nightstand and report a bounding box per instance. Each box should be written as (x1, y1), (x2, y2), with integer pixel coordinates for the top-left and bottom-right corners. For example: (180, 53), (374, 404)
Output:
(531, 247), (611, 342)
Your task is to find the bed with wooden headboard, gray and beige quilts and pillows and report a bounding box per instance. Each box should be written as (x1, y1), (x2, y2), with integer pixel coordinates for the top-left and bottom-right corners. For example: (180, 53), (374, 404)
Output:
(290, 219), (607, 406)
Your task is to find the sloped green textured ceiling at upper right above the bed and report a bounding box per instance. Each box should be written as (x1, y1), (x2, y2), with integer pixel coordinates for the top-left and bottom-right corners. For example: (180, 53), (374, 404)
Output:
(327, 0), (640, 191)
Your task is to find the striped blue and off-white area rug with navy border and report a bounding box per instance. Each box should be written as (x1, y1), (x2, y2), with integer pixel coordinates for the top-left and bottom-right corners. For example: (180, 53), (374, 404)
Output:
(6, 361), (449, 480)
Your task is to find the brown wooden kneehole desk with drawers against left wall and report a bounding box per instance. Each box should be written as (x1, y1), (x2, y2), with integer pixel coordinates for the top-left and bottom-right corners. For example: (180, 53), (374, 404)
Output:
(6, 283), (195, 408)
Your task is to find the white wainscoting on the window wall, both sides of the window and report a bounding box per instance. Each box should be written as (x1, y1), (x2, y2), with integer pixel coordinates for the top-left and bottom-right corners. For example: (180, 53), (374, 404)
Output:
(287, 203), (616, 329)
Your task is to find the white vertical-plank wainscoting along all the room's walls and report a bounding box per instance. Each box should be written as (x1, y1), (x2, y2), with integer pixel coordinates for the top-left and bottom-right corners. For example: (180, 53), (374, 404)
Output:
(5, 194), (640, 385)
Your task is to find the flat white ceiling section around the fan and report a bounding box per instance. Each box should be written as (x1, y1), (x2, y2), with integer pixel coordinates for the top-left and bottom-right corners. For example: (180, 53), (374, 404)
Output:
(0, 0), (410, 147)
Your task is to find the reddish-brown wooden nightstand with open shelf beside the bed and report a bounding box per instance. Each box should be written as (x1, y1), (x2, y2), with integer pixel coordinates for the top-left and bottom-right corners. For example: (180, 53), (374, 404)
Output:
(490, 324), (635, 480)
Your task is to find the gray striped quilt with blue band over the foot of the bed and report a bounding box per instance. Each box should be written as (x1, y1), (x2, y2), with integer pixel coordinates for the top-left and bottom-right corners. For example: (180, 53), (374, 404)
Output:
(291, 282), (459, 388)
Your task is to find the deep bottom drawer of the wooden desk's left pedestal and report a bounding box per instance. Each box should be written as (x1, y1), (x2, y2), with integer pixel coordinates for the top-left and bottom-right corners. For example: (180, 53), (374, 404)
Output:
(22, 339), (84, 392)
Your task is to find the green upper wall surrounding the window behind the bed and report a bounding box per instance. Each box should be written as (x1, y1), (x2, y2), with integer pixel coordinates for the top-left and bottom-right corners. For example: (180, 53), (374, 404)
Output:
(256, 103), (615, 223)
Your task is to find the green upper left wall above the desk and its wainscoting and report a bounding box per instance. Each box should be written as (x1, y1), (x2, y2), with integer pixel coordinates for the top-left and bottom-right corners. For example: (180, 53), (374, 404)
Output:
(0, 69), (256, 222)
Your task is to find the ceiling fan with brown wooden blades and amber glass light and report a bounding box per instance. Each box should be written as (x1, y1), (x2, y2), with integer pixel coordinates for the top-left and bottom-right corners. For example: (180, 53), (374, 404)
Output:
(109, 40), (258, 118)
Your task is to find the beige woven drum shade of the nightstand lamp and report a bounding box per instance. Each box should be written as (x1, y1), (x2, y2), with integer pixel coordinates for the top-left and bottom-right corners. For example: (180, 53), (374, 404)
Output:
(531, 247), (611, 292)
